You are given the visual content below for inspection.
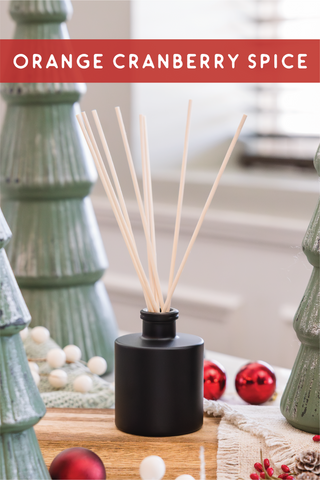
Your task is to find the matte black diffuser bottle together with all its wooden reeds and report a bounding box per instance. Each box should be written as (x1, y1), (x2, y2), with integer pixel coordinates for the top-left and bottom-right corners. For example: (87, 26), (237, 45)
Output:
(77, 100), (246, 437)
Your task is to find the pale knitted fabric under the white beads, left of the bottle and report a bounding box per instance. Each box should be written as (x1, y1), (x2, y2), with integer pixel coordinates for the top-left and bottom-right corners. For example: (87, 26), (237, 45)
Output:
(23, 328), (114, 408)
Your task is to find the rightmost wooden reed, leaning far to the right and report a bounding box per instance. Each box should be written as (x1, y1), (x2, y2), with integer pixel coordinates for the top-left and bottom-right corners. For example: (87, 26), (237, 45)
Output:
(162, 115), (247, 312)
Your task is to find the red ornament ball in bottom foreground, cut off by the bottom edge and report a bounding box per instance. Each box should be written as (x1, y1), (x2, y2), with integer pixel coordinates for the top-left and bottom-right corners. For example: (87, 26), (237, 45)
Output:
(49, 447), (107, 480)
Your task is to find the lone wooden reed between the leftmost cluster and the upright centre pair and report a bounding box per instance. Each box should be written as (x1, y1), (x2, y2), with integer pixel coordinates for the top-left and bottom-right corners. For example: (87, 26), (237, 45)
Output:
(116, 107), (164, 310)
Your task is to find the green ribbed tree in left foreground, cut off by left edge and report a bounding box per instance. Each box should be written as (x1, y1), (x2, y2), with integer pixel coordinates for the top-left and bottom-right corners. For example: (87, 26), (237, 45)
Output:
(0, 210), (50, 480)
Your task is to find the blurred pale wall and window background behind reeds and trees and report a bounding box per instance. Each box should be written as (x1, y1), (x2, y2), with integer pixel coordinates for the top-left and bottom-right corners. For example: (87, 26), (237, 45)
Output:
(0, 0), (320, 368)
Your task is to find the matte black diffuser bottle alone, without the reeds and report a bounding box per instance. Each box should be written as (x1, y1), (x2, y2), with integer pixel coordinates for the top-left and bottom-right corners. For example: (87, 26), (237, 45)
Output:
(115, 308), (204, 437)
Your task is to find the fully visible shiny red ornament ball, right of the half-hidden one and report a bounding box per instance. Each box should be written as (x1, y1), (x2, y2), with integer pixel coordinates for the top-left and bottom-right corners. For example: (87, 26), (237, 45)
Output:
(235, 361), (276, 405)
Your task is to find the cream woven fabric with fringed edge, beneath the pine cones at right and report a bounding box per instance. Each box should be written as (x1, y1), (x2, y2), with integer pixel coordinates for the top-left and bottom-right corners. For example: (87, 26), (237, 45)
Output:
(204, 400), (320, 480)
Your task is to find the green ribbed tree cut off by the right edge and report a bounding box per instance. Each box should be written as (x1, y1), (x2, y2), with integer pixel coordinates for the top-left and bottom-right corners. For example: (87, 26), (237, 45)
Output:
(281, 147), (320, 434)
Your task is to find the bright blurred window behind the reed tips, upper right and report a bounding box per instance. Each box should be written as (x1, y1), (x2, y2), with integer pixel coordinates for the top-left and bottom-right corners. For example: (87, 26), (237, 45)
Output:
(131, 0), (320, 171)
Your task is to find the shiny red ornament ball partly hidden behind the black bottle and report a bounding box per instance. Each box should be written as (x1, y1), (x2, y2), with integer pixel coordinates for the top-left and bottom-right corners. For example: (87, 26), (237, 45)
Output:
(203, 360), (227, 400)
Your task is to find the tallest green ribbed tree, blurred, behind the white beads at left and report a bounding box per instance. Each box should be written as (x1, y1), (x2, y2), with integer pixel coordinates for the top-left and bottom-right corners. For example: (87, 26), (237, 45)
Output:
(0, 0), (117, 372)
